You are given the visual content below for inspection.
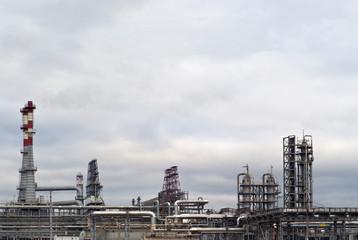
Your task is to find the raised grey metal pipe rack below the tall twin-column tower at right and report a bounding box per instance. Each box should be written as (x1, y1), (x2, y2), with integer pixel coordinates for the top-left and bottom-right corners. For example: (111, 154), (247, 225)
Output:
(238, 207), (358, 240)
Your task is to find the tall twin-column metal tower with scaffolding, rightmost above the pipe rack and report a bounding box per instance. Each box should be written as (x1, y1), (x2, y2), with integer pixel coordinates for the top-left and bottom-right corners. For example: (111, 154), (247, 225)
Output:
(283, 135), (313, 208)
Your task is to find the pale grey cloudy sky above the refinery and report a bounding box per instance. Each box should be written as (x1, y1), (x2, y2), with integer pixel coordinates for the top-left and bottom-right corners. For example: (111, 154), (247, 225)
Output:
(0, 0), (358, 209)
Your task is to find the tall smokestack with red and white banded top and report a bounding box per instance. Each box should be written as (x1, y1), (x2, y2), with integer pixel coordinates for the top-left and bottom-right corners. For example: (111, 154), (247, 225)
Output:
(18, 101), (37, 204)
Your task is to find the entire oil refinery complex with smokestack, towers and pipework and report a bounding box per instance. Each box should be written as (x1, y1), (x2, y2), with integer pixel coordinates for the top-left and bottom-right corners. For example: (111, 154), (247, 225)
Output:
(0, 101), (358, 240)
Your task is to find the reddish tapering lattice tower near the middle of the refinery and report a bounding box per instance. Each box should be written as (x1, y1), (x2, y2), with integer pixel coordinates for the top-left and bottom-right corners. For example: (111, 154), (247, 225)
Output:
(159, 166), (187, 203)
